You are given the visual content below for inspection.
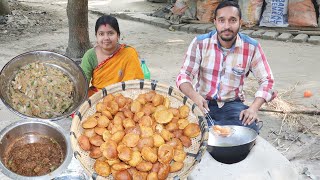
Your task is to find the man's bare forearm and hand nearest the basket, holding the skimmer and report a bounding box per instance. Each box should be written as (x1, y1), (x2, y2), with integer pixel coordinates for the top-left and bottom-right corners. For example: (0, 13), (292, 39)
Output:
(180, 82), (209, 112)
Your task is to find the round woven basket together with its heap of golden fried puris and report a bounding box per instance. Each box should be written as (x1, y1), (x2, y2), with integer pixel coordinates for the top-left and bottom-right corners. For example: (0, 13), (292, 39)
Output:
(70, 80), (208, 179)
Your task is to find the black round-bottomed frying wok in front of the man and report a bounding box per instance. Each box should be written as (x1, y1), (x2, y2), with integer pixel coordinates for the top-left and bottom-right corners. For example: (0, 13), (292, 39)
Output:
(207, 125), (262, 164)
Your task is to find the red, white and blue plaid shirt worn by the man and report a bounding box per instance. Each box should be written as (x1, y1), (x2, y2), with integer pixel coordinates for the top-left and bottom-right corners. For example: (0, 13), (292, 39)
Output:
(176, 31), (274, 102)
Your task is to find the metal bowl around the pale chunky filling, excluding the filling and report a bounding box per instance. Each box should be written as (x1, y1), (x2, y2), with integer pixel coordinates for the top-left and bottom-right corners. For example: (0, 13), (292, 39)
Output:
(0, 51), (88, 120)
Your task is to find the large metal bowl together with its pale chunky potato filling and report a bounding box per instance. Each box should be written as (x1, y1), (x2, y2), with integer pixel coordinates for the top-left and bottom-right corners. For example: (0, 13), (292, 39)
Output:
(0, 51), (88, 120)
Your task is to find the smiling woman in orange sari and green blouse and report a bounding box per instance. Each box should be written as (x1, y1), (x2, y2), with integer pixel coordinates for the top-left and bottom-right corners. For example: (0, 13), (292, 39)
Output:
(80, 15), (143, 97)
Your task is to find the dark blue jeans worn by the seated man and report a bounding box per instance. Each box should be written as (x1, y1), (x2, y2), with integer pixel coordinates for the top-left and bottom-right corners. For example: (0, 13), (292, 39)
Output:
(207, 100), (259, 133)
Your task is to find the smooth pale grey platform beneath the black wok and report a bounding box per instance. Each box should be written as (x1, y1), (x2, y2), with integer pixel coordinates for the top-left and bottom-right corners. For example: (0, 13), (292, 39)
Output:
(188, 136), (298, 180)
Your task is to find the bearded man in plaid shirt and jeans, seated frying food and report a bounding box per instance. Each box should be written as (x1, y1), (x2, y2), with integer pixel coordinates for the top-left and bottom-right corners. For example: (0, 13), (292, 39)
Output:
(176, 1), (275, 132)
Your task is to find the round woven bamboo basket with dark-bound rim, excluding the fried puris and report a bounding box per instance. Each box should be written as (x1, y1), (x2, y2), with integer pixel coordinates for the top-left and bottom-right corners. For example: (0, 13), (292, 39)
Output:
(70, 80), (208, 179)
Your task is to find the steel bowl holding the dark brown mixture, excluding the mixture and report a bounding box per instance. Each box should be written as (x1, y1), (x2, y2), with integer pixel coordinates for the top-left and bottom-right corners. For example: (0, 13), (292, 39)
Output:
(0, 120), (72, 180)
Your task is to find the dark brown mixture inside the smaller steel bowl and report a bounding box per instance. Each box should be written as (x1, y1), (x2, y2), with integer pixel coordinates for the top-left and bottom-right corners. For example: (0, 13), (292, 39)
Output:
(4, 135), (63, 176)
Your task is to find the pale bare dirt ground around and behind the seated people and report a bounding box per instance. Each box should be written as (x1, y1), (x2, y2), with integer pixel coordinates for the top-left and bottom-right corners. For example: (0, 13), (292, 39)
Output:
(0, 0), (320, 179)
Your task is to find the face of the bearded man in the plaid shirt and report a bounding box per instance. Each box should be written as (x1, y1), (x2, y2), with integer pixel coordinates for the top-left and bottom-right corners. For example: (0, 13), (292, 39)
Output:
(214, 6), (241, 42)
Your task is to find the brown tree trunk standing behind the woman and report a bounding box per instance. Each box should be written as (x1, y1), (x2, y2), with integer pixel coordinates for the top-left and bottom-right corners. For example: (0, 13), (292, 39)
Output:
(66, 0), (91, 58)
